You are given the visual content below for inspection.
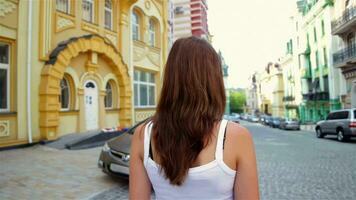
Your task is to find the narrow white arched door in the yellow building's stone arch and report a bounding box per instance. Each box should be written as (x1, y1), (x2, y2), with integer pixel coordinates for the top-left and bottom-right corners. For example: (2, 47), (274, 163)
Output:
(84, 80), (99, 130)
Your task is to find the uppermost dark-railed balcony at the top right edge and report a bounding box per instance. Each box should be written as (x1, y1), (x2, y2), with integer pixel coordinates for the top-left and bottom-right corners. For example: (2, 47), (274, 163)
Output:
(331, 7), (356, 35)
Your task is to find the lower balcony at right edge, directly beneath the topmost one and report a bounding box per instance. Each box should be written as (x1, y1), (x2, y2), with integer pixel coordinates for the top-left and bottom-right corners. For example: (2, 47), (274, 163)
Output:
(333, 43), (356, 67)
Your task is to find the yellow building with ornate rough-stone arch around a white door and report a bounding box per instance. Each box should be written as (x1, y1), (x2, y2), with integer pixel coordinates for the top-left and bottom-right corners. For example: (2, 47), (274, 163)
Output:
(0, 0), (168, 147)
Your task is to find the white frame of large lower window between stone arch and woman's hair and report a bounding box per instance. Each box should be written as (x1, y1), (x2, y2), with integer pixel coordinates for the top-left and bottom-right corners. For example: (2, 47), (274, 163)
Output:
(133, 70), (156, 108)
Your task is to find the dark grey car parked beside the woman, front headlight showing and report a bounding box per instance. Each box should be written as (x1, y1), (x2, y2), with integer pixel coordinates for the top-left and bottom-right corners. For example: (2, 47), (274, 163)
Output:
(98, 119), (147, 177)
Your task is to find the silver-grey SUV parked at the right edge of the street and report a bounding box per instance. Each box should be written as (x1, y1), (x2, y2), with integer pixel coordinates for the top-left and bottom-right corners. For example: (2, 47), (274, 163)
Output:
(315, 108), (356, 141)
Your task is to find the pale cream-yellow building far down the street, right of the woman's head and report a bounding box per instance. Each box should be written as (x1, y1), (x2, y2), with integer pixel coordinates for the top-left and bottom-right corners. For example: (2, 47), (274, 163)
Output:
(257, 63), (284, 117)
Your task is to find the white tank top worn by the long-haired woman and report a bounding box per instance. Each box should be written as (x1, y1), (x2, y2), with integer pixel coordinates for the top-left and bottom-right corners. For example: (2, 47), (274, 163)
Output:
(144, 120), (236, 200)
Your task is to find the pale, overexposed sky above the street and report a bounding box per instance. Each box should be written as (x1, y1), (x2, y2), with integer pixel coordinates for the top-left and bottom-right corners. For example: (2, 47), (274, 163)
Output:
(208, 0), (296, 88)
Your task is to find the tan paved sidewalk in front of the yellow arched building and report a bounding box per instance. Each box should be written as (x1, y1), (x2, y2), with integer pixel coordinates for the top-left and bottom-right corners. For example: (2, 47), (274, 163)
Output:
(0, 145), (127, 200)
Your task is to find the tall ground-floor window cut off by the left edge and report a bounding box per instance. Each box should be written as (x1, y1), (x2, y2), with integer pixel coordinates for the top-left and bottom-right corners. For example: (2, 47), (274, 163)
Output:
(0, 43), (10, 112)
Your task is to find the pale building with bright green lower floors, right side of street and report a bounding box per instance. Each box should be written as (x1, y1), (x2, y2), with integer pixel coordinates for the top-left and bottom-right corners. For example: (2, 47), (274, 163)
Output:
(297, 0), (342, 122)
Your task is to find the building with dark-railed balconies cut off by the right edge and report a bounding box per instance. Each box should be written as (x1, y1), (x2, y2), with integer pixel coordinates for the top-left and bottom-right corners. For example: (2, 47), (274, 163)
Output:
(331, 0), (356, 108)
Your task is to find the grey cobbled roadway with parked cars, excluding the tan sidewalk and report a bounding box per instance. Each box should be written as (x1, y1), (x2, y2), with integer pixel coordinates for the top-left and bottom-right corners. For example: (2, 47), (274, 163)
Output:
(92, 122), (356, 200)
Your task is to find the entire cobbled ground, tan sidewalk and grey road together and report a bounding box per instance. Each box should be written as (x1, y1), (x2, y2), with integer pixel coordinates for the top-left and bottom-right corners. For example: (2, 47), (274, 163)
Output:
(0, 122), (356, 200)
